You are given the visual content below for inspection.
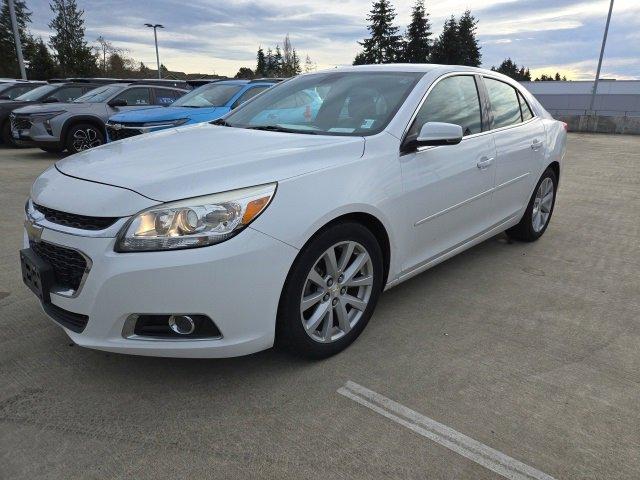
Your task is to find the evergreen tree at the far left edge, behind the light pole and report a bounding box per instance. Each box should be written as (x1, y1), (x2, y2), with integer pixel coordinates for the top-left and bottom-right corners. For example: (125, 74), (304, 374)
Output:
(0, 0), (33, 78)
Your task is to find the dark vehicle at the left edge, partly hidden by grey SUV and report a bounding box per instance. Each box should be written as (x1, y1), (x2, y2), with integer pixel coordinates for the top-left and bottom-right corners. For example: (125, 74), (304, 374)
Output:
(0, 82), (100, 146)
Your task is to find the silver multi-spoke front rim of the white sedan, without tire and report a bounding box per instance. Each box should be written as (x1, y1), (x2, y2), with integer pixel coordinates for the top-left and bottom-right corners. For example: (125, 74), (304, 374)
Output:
(300, 241), (373, 343)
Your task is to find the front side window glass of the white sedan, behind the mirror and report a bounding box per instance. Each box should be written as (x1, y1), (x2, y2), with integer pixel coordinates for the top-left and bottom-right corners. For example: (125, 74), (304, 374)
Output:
(407, 75), (482, 138)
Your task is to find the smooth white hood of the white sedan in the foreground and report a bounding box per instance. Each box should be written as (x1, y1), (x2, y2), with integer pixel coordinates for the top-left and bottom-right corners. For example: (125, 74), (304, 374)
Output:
(56, 123), (364, 202)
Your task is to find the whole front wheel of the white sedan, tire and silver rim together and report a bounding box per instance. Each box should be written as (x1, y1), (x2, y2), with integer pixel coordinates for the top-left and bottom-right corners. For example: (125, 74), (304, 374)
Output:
(276, 222), (384, 358)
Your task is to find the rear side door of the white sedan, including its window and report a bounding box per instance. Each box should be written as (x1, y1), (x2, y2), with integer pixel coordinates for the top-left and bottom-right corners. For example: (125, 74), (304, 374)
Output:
(483, 76), (546, 222)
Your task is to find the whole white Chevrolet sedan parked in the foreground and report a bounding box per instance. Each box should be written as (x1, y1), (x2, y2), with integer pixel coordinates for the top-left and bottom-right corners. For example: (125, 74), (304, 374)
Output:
(20, 65), (566, 358)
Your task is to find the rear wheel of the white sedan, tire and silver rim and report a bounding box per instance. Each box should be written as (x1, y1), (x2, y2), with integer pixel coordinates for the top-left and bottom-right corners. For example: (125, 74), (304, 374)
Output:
(507, 168), (558, 242)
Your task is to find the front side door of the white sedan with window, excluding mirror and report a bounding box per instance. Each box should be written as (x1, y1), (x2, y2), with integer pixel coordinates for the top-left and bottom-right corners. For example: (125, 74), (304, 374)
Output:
(400, 74), (496, 270)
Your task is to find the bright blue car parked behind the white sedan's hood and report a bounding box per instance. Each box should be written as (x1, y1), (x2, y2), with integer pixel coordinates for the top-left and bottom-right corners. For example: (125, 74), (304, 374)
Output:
(106, 79), (278, 141)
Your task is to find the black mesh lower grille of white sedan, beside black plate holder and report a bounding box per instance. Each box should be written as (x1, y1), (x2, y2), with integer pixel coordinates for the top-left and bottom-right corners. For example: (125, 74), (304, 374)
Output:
(29, 241), (87, 291)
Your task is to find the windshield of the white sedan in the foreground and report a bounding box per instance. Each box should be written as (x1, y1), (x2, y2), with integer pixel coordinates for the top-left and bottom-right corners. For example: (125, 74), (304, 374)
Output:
(224, 72), (423, 136)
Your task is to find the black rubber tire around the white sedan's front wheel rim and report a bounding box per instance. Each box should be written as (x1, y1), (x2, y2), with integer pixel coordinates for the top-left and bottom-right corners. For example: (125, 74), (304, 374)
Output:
(276, 222), (384, 359)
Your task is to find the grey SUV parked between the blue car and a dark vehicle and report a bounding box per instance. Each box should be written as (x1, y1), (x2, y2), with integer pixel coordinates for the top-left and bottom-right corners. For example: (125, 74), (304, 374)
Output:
(11, 82), (187, 153)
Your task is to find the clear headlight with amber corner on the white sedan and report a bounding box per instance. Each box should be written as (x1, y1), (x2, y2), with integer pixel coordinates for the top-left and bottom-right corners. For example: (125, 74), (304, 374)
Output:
(115, 183), (277, 252)
